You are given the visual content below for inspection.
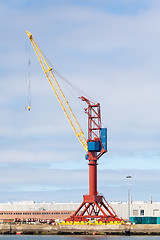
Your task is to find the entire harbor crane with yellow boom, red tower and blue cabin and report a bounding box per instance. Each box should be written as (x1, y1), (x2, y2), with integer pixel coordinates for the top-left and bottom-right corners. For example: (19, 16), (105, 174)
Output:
(26, 31), (122, 222)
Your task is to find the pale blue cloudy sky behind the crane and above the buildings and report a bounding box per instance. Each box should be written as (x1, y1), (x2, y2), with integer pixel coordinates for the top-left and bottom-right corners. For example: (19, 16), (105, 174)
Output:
(0, 0), (160, 202)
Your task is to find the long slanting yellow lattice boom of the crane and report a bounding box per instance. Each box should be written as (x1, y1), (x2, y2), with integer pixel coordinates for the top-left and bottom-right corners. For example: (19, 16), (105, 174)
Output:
(26, 31), (88, 151)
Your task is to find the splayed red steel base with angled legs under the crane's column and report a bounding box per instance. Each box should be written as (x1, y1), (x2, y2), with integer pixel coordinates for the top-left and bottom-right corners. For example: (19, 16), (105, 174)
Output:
(65, 195), (123, 222)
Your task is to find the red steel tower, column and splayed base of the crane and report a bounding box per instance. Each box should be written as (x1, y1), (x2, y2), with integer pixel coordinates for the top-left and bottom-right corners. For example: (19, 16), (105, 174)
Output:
(66, 97), (122, 222)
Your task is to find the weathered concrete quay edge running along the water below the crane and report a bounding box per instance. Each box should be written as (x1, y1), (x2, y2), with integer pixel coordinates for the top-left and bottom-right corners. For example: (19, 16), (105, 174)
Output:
(0, 224), (160, 235)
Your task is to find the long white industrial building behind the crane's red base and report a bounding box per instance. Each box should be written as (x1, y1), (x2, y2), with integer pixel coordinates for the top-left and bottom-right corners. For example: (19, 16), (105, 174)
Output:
(0, 201), (160, 220)
